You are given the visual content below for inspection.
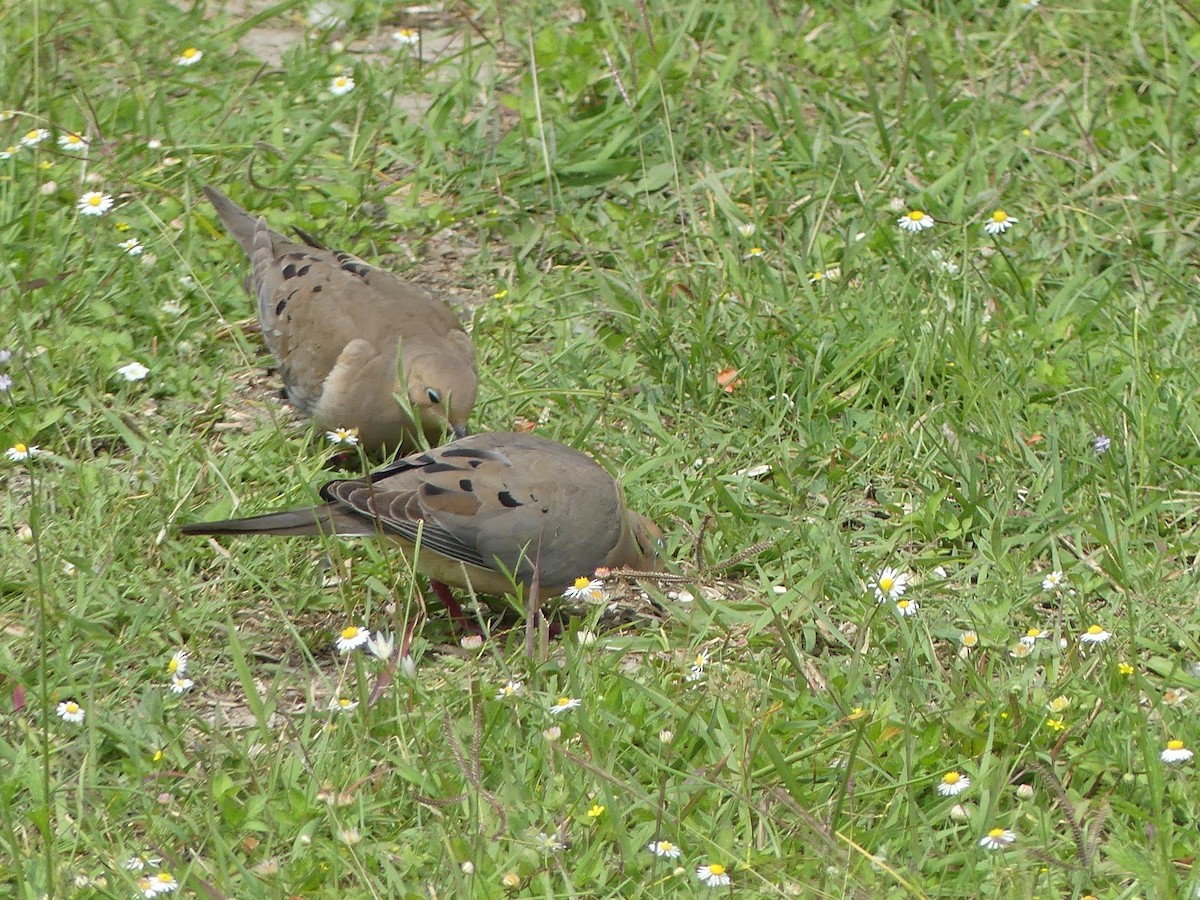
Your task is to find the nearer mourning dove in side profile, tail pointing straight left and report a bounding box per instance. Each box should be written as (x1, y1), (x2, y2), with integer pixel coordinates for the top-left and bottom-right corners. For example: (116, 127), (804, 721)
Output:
(182, 432), (661, 594)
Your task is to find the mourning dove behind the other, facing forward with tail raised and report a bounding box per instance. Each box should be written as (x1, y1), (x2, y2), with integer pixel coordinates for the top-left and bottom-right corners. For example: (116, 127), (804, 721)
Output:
(204, 187), (476, 454)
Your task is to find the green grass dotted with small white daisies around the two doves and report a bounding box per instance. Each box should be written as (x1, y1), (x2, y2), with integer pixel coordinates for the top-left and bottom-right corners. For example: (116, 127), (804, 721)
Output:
(0, 0), (1200, 899)
